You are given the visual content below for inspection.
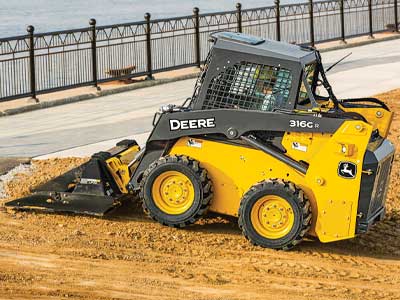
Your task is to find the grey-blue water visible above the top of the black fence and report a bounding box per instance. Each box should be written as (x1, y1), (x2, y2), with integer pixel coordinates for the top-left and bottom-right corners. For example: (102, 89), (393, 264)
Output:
(0, 0), (305, 37)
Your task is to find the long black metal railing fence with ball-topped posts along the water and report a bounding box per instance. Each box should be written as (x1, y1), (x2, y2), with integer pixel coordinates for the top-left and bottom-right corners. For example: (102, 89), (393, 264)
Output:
(0, 0), (400, 101)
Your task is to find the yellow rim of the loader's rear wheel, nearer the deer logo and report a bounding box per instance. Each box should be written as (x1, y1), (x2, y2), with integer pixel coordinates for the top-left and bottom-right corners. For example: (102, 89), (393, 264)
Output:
(250, 195), (294, 239)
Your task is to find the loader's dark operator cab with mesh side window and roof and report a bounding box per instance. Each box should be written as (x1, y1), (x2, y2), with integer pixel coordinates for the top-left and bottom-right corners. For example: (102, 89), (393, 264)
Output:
(191, 32), (318, 111)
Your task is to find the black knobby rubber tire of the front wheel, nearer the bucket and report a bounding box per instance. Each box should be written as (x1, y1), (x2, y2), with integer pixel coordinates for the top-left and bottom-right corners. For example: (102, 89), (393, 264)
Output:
(139, 156), (213, 228)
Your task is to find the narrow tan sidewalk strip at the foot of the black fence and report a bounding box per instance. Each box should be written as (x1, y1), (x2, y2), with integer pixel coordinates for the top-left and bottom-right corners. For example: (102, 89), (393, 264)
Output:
(0, 32), (400, 117)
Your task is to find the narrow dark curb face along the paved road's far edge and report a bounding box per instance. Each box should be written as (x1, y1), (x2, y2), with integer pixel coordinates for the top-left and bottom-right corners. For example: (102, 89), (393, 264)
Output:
(0, 34), (400, 117)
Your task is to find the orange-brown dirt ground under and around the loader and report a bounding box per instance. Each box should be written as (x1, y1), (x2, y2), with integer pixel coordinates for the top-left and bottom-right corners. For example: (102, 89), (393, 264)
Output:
(0, 90), (400, 300)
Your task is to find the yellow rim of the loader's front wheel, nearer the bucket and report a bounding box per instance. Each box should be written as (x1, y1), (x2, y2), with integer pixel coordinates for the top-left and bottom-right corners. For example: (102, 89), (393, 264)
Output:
(151, 171), (194, 215)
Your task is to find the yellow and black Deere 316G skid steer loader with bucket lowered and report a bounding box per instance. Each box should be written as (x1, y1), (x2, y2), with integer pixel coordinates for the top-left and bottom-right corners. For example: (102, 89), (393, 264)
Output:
(7, 32), (394, 250)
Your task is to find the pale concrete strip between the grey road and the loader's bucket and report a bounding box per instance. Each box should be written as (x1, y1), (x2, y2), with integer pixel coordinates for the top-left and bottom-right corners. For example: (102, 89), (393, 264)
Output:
(33, 132), (150, 160)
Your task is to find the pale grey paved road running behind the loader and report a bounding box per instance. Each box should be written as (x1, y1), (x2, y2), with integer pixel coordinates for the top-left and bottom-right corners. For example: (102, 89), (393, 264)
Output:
(0, 39), (400, 157)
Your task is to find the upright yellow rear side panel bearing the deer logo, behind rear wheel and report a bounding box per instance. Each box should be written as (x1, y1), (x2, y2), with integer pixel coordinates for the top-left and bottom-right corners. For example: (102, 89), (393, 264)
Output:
(306, 121), (372, 242)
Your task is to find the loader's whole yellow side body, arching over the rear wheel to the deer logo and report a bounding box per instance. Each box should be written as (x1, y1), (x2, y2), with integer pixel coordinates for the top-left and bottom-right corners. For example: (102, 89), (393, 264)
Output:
(170, 121), (372, 242)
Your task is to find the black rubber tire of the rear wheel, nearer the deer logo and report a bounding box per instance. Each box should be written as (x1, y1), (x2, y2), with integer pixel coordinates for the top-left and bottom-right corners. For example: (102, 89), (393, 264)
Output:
(238, 179), (312, 250)
